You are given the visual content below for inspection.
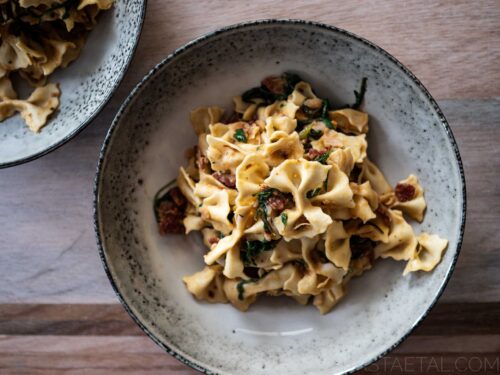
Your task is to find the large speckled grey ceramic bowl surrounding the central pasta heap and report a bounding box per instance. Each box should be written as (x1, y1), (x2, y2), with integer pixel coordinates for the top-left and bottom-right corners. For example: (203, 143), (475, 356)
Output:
(95, 21), (465, 375)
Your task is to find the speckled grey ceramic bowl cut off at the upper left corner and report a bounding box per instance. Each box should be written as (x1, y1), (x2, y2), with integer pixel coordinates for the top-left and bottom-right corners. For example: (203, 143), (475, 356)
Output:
(0, 0), (146, 168)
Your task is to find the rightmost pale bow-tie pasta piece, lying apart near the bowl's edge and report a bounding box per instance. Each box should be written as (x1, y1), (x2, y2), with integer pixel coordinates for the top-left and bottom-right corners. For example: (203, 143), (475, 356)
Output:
(403, 233), (448, 275)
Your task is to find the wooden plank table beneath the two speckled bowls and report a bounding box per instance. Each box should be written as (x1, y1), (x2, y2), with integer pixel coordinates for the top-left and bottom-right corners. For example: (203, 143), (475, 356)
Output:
(0, 0), (500, 374)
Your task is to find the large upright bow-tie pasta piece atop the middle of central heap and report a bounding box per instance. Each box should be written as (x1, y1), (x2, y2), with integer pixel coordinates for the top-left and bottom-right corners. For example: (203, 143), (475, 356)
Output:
(264, 159), (332, 241)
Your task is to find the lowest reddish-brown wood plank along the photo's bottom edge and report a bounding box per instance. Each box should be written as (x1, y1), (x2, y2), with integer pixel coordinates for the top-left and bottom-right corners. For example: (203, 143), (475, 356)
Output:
(0, 336), (500, 375)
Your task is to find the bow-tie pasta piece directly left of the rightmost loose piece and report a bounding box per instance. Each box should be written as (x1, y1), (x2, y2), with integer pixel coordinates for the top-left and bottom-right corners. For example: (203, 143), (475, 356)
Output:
(375, 209), (417, 260)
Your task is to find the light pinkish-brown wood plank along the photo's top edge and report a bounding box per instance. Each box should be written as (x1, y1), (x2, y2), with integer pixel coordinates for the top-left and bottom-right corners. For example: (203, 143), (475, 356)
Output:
(119, 0), (500, 99)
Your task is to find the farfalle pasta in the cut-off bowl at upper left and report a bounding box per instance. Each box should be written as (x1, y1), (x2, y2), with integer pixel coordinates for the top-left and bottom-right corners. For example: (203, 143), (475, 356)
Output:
(0, 0), (113, 133)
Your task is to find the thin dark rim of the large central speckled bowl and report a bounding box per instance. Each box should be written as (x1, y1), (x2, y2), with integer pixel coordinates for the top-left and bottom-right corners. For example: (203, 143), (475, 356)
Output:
(94, 19), (467, 374)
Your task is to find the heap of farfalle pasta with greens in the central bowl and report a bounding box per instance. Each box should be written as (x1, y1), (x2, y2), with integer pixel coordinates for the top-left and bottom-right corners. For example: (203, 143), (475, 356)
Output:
(153, 73), (448, 314)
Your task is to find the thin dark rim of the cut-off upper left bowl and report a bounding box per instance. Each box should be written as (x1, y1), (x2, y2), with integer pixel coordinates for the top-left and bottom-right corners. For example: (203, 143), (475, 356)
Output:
(0, 0), (148, 169)
